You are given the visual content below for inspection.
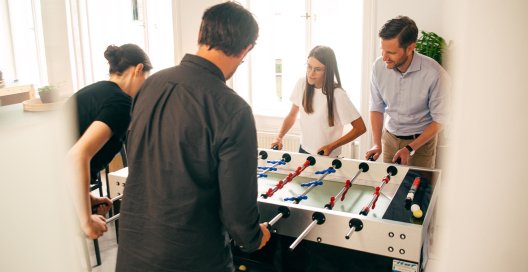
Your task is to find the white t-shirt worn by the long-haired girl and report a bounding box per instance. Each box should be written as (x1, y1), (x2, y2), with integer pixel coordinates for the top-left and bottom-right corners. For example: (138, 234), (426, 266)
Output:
(290, 77), (361, 157)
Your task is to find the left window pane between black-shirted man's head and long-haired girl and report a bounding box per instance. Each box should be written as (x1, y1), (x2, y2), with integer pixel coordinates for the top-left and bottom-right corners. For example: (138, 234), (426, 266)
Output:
(235, 0), (306, 116)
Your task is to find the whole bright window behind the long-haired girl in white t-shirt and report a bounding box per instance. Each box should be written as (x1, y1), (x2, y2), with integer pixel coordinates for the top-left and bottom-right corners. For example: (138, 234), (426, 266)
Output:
(233, 0), (363, 117)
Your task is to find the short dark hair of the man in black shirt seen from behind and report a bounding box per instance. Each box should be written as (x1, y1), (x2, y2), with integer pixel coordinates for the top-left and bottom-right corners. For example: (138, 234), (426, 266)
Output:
(198, 2), (259, 56)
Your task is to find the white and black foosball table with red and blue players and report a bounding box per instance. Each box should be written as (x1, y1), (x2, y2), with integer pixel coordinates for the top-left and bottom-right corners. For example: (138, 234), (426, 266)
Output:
(109, 149), (441, 272)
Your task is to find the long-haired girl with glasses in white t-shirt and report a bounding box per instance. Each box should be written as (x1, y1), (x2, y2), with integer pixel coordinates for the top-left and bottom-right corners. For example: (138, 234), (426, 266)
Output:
(271, 46), (366, 157)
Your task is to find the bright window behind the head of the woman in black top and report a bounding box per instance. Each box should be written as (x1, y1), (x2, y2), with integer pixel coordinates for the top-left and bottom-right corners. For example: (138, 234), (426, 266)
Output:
(76, 0), (174, 87)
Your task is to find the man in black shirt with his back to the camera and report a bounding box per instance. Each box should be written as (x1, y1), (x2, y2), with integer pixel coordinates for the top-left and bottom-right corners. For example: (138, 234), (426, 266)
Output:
(116, 2), (270, 272)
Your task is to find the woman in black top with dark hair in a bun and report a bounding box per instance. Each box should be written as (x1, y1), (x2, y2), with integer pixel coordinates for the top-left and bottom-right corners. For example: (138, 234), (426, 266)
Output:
(68, 44), (152, 239)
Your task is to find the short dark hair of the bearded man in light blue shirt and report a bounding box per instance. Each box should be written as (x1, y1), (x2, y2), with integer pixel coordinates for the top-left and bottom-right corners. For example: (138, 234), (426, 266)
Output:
(379, 16), (418, 48)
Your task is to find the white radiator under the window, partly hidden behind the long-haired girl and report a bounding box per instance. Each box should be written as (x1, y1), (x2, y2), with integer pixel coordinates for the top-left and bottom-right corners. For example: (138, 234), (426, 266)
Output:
(257, 132), (357, 159)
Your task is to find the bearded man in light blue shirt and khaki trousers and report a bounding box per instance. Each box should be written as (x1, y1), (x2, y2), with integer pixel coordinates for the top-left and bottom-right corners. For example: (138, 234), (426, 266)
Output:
(365, 16), (449, 168)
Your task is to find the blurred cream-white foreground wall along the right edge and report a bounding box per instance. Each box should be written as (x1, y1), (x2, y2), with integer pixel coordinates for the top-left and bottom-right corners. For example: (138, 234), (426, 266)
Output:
(437, 0), (528, 272)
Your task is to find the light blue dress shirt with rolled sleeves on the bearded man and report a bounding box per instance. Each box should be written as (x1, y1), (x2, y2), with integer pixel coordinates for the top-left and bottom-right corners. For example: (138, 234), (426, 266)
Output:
(370, 51), (450, 136)
